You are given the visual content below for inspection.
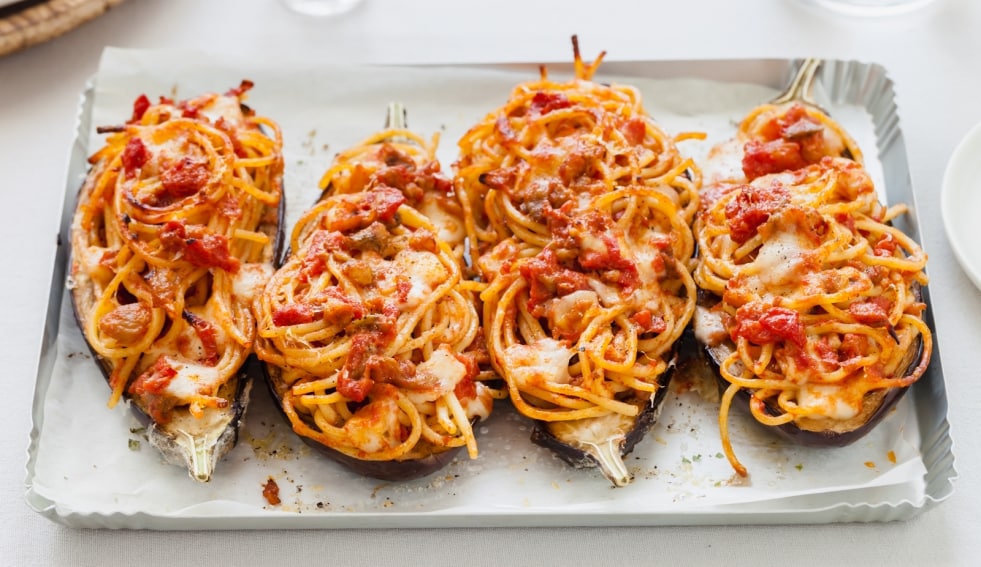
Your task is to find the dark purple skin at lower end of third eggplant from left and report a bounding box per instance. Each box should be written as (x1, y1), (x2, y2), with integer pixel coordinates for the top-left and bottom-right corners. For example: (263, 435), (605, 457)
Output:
(531, 364), (676, 478)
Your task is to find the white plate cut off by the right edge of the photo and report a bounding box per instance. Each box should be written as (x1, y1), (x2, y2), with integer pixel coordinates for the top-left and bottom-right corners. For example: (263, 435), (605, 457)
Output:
(940, 124), (981, 289)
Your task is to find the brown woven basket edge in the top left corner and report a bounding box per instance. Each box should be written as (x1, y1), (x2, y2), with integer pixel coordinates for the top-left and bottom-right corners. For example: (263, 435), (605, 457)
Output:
(0, 0), (123, 55)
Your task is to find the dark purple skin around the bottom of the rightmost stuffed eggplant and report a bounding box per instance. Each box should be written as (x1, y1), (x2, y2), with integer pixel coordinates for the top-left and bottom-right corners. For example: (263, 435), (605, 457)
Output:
(682, 287), (925, 448)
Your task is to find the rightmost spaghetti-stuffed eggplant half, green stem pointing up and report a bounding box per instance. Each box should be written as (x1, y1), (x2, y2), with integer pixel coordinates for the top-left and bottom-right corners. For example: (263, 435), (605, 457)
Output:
(694, 59), (933, 476)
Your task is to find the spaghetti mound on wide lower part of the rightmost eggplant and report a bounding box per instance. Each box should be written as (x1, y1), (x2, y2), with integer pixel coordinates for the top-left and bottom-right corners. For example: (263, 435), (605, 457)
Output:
(695, 157), (932, 475)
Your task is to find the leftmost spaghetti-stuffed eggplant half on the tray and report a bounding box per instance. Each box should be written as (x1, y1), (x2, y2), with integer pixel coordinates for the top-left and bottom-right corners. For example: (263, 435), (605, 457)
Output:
(68, 81), (283, 481)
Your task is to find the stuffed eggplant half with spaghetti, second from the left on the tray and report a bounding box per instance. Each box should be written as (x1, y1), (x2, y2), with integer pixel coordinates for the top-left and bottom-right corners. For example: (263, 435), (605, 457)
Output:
(254, 117), (502, 480)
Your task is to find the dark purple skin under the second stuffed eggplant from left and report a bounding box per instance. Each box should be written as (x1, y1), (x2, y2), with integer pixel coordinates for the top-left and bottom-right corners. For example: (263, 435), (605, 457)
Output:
(261, 363), (479, 482)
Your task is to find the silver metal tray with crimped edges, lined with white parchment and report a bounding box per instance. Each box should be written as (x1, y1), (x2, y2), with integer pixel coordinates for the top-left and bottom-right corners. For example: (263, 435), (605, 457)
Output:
(26, 49), (957, 529)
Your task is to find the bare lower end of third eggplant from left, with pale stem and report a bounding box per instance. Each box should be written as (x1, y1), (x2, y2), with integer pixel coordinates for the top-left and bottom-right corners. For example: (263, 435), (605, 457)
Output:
(531, 361), (675, 487)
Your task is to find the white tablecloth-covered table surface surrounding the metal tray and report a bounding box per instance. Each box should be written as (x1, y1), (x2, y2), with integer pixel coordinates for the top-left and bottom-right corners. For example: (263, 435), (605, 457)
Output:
(0, 0), (981, 566)
